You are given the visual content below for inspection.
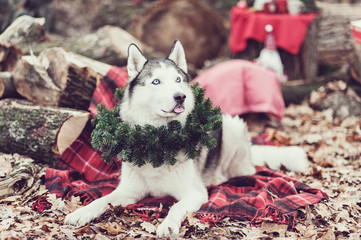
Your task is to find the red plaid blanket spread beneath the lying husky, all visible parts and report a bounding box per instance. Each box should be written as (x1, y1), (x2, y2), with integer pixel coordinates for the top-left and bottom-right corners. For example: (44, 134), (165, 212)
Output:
(45, 67), (327, 225)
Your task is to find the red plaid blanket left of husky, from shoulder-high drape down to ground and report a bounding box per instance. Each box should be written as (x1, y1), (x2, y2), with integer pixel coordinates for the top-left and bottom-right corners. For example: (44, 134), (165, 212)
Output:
(45, 67), (128, 205)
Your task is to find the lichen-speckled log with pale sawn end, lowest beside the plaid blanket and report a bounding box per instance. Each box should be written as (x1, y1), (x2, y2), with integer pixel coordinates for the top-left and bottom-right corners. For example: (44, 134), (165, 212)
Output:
(0, 99), (89, 164)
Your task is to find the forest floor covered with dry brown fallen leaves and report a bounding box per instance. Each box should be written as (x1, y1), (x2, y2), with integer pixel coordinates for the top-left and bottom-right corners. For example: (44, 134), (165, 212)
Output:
(0, 83), (361, 239)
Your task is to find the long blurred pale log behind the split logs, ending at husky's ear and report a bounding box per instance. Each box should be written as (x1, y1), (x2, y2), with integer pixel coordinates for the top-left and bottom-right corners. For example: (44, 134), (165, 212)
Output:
(26, 26), (146, 66)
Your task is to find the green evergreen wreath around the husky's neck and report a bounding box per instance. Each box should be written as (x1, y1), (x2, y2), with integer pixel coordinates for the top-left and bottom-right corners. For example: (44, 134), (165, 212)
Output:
(91, 84), (222, 168)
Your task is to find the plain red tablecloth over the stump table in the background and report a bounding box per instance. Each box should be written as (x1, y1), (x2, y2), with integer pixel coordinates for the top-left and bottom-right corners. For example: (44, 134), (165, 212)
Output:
(229, 6), (315, 54)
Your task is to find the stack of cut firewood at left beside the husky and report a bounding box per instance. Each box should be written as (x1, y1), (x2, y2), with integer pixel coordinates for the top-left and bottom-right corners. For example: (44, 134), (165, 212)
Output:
(0, 16), (134, 164)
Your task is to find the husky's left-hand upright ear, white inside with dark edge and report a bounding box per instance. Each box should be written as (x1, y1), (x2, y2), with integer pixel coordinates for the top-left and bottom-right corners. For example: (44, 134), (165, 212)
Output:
(127, 43), (148, 80)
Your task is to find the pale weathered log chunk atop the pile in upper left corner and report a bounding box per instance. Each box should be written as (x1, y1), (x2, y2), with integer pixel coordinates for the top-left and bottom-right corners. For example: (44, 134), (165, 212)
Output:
(0, 15), (46, 50)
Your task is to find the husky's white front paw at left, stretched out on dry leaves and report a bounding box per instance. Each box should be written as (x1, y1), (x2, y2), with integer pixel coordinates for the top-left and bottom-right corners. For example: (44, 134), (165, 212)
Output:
(64, 206), (103, 226)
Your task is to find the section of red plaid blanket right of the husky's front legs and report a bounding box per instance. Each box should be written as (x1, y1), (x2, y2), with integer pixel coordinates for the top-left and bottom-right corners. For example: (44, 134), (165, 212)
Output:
(198, 167), (327, 225)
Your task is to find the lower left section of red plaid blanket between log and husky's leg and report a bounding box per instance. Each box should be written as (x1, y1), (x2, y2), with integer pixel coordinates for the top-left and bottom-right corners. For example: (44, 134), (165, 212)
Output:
(45, 123), (120, 205)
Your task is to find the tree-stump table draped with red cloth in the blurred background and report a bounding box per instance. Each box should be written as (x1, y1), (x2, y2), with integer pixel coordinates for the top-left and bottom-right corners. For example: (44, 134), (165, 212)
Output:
(229, 6), (319, 82)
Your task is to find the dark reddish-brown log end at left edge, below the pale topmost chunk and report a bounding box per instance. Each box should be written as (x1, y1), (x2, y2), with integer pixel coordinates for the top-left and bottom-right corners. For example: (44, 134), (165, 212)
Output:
(0, 43), (24, 72)
